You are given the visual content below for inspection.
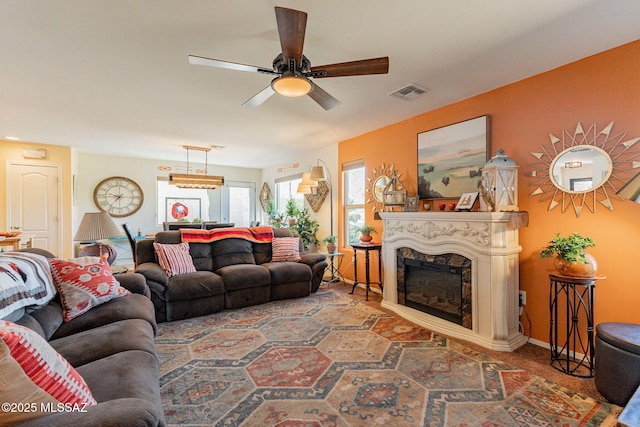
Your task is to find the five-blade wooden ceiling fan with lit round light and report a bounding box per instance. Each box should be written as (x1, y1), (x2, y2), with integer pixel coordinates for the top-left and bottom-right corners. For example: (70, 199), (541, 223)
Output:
(189, 6), (389, 110)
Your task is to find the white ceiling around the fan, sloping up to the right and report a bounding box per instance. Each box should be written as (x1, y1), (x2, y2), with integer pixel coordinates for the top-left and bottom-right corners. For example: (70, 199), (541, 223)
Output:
(0, 0), (640, 168)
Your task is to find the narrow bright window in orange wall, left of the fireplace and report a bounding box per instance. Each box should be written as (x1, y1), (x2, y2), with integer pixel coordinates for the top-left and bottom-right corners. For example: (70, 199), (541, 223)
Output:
(342, 161), (366, 245)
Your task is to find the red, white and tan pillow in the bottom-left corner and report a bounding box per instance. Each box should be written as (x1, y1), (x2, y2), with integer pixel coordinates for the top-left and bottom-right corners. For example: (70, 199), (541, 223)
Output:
(0, 321), (96, 425)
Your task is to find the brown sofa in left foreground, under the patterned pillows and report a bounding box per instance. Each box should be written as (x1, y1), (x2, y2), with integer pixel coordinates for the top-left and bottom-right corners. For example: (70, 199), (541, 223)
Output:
(4, 250), (165, 427)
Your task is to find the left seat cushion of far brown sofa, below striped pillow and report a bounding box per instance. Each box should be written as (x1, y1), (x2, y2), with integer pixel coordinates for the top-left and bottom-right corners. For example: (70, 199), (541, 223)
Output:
(165, 271), (224, 301)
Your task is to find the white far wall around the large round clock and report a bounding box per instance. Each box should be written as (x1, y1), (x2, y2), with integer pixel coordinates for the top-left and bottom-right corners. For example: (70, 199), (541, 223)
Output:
(72, 153), (262, 234)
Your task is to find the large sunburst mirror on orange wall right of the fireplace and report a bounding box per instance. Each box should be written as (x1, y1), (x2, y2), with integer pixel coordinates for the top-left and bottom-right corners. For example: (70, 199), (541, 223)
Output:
(528, 122), (640, 217)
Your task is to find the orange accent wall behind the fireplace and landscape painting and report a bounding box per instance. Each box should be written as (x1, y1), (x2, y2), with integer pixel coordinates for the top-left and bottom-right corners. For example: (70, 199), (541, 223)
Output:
(338, 41), (640, 342)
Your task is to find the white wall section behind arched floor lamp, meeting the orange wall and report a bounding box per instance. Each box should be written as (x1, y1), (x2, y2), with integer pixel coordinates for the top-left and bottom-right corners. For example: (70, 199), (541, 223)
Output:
(256, 144), (340, 250)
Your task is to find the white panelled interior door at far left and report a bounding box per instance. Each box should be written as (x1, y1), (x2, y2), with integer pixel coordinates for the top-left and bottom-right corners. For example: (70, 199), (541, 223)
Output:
(7, 163), (62, 255)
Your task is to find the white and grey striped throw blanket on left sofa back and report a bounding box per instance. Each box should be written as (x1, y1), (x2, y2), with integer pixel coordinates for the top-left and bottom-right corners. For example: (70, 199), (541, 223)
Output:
(0, 252), (56, 319)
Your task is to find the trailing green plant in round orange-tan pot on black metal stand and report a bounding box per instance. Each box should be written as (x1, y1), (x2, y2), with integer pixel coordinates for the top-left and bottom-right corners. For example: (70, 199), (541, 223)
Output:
(540, 232), (598, 277)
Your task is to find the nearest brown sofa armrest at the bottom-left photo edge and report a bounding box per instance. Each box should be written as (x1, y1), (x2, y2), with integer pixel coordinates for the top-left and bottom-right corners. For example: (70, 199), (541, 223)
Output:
(19, 398), (165, 427)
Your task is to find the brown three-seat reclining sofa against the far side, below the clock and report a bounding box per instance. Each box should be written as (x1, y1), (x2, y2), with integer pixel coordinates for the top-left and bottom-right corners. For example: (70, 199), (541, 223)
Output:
(136, 228), (327, 322)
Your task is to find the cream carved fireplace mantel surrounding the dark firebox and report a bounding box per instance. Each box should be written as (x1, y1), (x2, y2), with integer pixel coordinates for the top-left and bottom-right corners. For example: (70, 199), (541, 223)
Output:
(380, 212), (526, 351)
